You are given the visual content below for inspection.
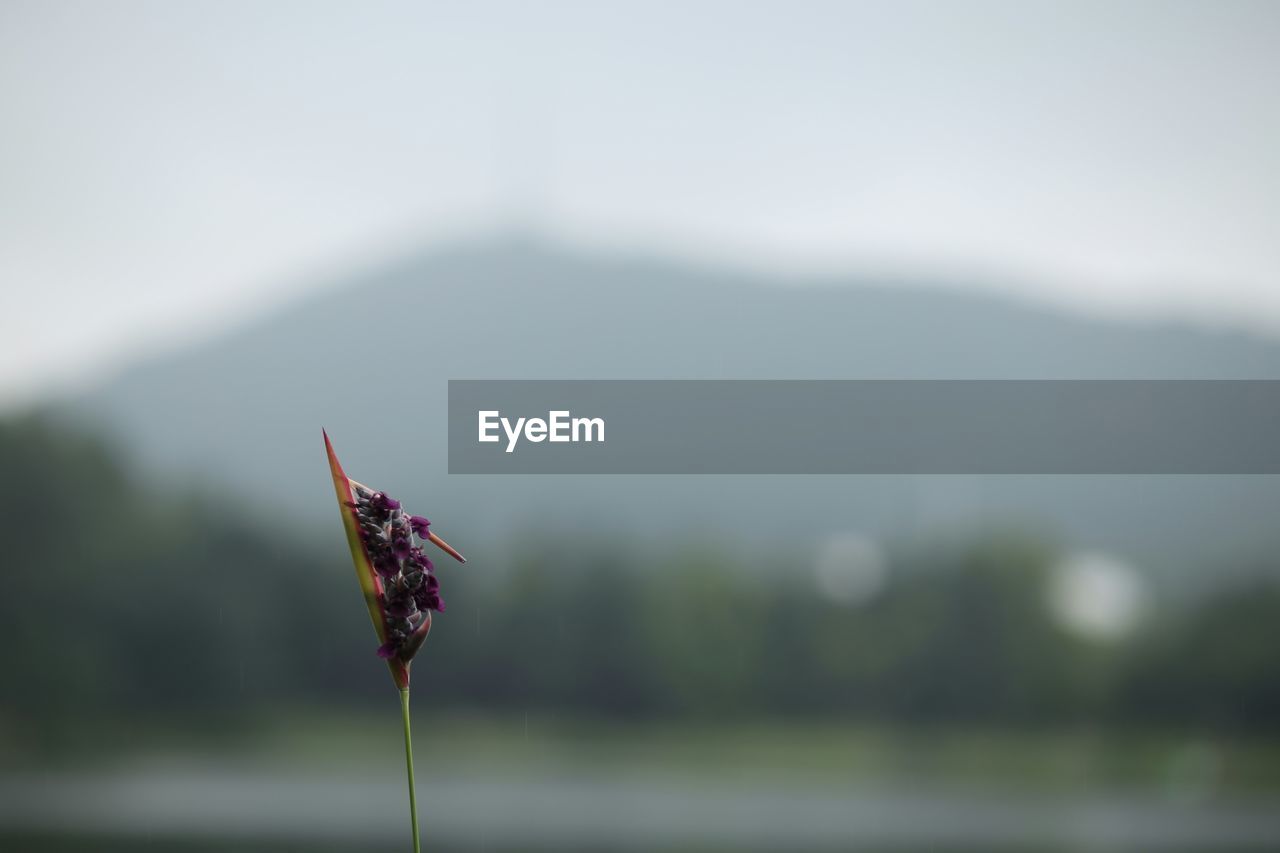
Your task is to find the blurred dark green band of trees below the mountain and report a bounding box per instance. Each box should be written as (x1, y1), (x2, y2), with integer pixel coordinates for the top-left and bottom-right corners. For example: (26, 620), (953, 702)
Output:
(0, 419), (1280, 729)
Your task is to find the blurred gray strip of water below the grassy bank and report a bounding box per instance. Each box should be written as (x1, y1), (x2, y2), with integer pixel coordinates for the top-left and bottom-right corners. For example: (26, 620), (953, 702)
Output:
(0, 767), (1280, 853)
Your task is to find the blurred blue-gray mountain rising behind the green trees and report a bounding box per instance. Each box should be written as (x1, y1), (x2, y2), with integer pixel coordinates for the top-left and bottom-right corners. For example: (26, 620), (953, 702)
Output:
(63, 235), (1280, 589)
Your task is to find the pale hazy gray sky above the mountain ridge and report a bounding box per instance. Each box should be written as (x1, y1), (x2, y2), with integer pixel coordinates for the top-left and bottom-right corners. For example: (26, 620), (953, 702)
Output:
(0, 0), (1280, 401)
